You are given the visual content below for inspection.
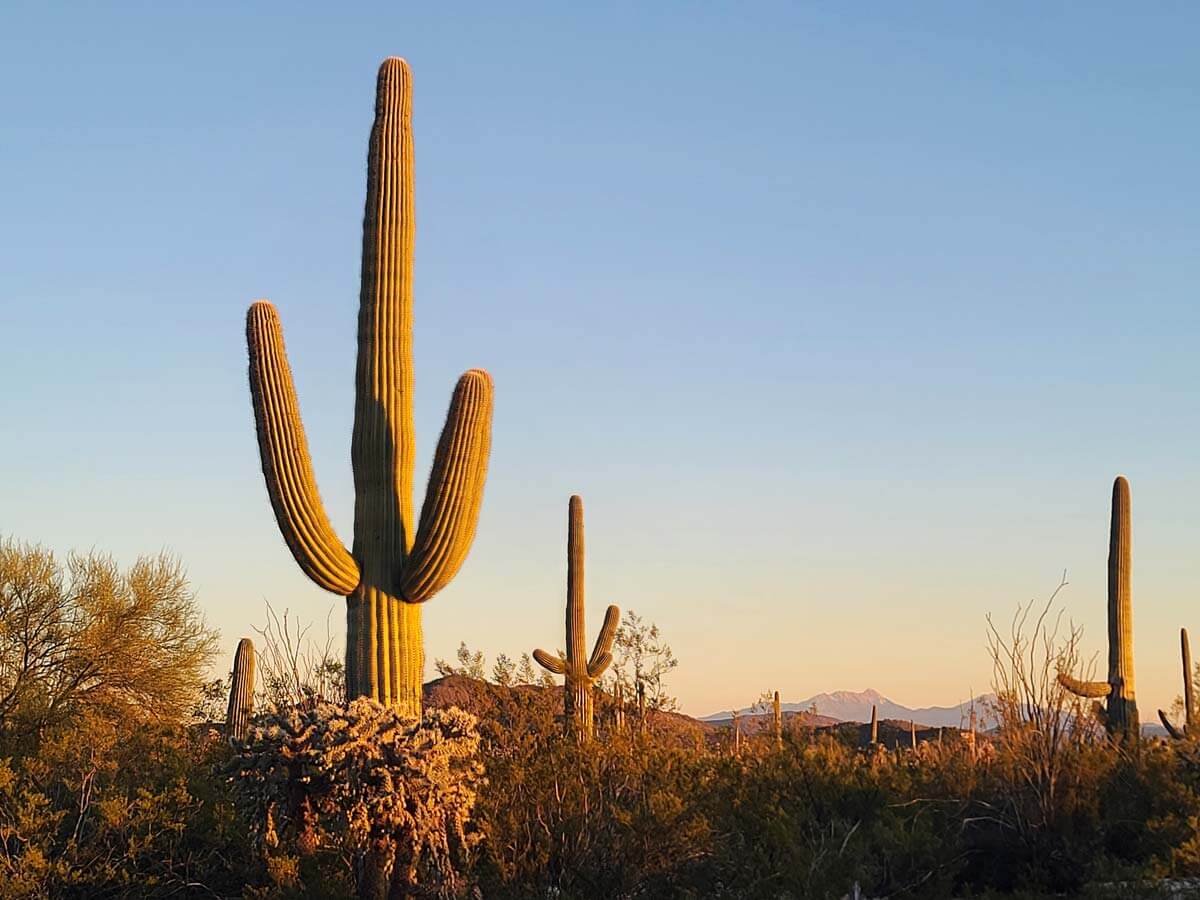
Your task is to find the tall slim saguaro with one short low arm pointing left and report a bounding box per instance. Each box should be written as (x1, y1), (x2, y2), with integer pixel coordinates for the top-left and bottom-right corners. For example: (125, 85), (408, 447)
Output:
(1058, 475), (1138, 737)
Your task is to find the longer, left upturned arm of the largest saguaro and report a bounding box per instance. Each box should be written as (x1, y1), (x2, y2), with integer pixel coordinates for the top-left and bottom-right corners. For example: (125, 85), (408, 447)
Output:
(246, 300), (359, 595)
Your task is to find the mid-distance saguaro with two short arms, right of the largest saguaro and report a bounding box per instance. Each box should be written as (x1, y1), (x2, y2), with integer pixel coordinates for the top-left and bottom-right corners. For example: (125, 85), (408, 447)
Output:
(533, 496), (620, 740)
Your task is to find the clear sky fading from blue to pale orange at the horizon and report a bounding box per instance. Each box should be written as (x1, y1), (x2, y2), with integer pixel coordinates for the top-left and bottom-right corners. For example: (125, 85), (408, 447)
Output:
(0, 0), (1200, 720)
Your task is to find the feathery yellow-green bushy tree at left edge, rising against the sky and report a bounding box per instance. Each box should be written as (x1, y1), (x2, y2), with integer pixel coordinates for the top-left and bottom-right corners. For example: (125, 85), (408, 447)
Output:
(0, 541), (217, 754)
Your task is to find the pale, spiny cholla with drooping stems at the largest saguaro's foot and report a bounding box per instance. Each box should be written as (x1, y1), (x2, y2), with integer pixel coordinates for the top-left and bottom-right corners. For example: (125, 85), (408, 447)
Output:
(232, 697), (484, 896)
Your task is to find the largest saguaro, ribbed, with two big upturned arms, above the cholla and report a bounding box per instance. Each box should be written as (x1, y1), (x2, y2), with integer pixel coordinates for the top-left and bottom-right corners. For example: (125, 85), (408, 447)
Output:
(246, 59), (492, 715)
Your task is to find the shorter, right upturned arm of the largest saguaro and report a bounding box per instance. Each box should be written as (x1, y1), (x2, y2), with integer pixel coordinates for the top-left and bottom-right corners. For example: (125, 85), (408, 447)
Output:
(400, 368), (492, 604)
